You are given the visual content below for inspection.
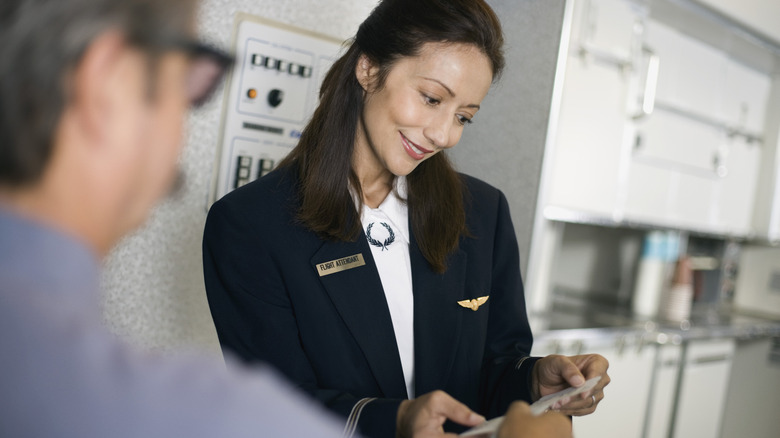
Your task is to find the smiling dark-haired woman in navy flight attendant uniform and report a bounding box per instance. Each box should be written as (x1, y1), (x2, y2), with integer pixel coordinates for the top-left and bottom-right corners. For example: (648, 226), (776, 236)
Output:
(203, 0), (608, 436)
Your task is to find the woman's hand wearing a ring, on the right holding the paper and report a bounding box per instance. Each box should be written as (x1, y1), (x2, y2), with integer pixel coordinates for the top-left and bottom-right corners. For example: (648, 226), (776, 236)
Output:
(531, 354), (610, 416)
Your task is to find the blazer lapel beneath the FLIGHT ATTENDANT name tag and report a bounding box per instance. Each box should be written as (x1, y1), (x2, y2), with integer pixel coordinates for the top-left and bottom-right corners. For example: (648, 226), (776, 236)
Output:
(311, 235), (407, 398)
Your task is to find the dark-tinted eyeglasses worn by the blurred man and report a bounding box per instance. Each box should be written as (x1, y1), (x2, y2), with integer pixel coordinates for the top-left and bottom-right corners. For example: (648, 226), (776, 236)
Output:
(149, 38), (235, 108)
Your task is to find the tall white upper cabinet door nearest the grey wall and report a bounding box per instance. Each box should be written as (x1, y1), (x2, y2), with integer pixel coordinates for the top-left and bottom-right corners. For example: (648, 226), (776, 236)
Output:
(548, 0), (643, 217)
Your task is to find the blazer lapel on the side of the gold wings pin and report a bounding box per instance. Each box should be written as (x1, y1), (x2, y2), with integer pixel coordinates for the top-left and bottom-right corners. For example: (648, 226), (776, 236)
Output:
(409, 233), (467, 395)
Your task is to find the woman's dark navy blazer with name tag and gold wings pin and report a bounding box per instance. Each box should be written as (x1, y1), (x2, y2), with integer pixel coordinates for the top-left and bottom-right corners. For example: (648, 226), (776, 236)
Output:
(203, 166), (535, 437)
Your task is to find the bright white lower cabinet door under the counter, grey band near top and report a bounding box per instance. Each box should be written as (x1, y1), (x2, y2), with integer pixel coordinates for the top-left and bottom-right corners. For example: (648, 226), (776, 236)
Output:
(672, 339), (735, 438)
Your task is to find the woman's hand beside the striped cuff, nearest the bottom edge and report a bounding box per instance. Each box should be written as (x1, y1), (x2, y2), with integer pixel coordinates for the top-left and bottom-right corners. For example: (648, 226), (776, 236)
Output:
(395, 391), (485, 438)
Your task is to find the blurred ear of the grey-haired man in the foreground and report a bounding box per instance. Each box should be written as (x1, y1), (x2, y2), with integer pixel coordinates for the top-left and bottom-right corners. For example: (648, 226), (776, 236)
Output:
(65, 31), (129, 144)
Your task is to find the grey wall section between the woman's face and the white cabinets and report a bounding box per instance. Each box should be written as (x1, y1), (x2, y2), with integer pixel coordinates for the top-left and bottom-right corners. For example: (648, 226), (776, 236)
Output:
(450, 0), (565, 274)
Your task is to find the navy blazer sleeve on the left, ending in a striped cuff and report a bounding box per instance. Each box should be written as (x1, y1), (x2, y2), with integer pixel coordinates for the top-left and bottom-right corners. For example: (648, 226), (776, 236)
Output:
(203, 198), (402, 437)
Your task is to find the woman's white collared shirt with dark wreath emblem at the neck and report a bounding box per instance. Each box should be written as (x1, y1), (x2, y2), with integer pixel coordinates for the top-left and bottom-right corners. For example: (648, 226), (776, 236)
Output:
(360, 177), (414, 399)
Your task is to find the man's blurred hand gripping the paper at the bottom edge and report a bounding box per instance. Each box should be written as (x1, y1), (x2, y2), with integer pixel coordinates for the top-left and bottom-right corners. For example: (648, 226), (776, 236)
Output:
(498, 401), (572, 438)
